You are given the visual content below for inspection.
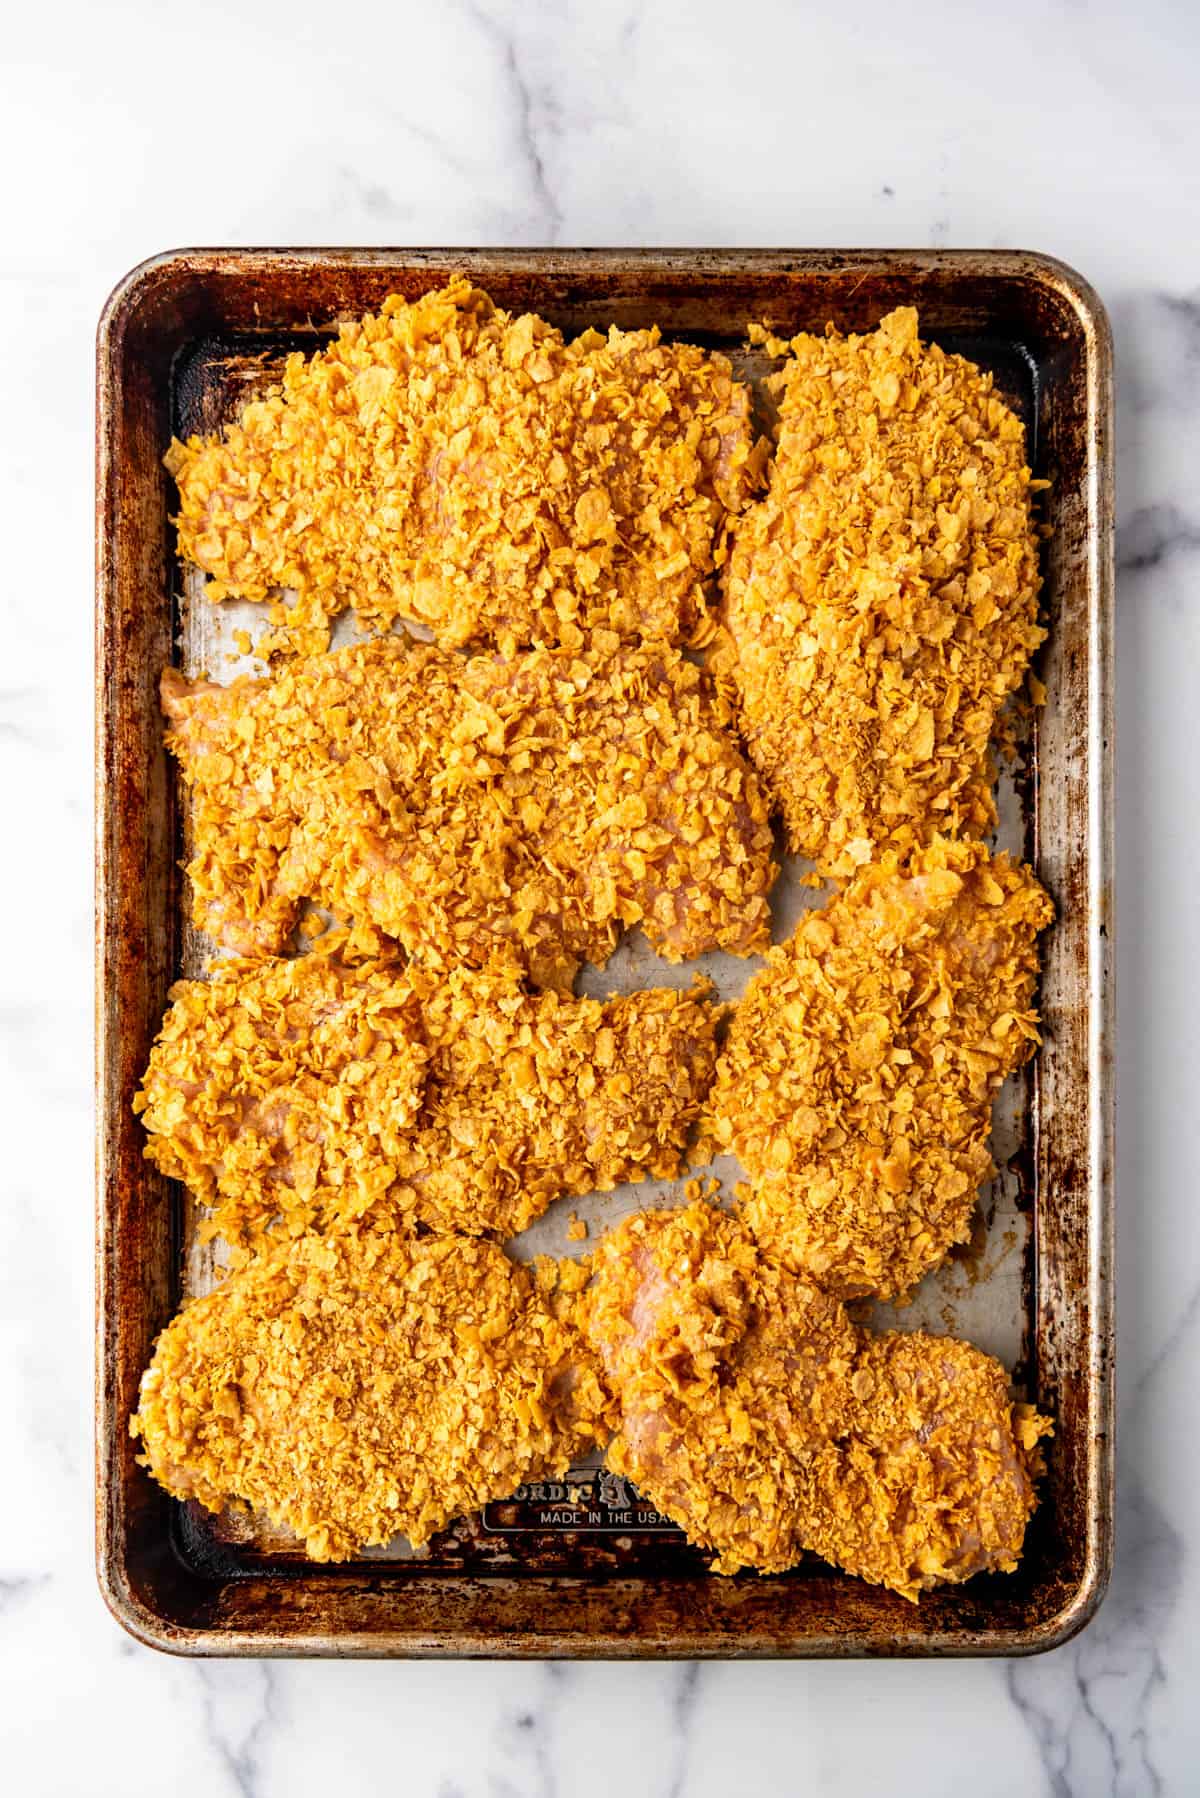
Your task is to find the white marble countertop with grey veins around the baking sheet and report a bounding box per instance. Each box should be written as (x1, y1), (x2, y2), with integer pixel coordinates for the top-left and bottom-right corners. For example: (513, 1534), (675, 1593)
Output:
(0, 0), (1200, 1798)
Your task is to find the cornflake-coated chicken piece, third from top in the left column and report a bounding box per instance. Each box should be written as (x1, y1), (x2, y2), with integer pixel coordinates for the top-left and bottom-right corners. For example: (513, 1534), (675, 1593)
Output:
(135, 937), (718, 1244)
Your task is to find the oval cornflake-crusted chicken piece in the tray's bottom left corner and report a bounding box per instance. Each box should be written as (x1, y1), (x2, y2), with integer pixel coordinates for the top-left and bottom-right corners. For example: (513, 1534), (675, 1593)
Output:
(130, 1232), (608, 1561)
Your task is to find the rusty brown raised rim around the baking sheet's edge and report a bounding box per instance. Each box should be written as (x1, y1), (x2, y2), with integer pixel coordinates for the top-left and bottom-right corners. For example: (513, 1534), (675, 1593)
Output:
(95, 248), (1114, 1660)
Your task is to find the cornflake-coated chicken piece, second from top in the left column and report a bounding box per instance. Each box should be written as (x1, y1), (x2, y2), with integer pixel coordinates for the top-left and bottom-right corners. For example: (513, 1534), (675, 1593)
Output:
(162, 633), (775, 985)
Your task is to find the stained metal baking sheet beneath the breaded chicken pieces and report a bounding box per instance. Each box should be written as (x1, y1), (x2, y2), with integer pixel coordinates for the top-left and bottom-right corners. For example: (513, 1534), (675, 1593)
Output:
(97, 250), (1112, 1658)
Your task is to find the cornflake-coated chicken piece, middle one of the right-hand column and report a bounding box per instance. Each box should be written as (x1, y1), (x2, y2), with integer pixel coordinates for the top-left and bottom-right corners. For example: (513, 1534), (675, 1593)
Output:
(698, 838), (1052, 1298)
